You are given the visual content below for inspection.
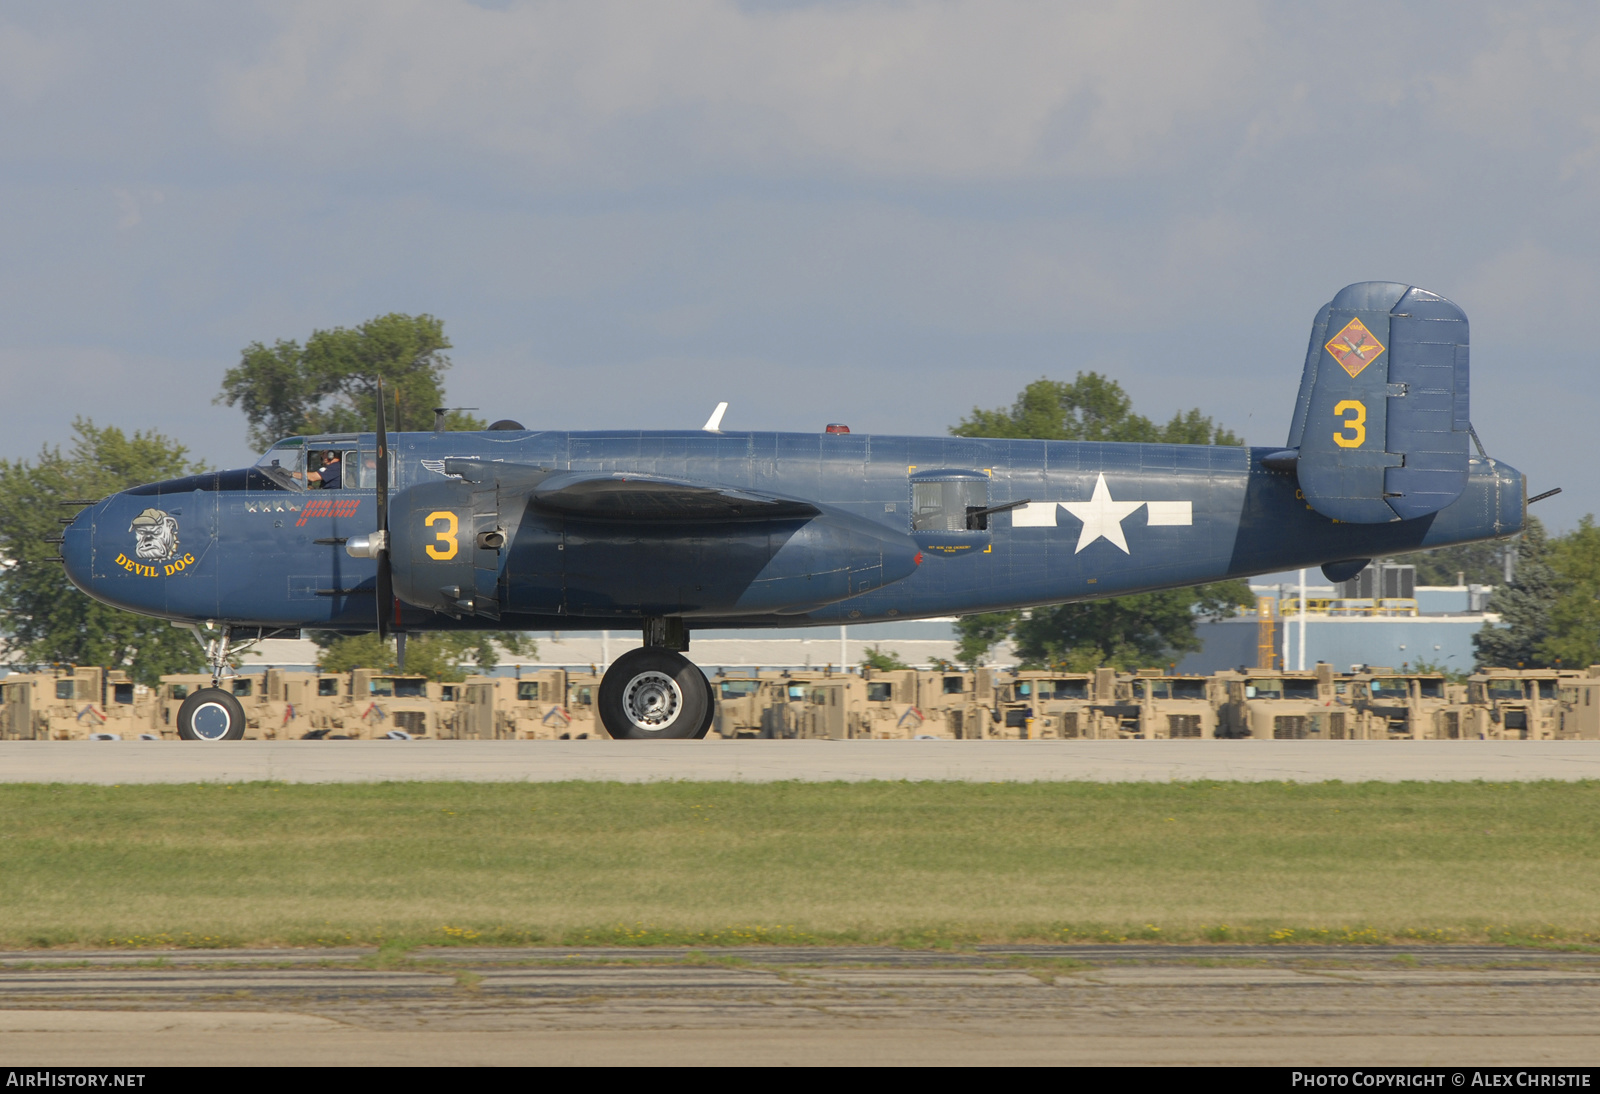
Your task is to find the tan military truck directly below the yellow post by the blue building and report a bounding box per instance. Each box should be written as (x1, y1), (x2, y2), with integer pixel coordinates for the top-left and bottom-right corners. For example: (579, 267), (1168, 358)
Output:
(1214, 664), (1362, 741)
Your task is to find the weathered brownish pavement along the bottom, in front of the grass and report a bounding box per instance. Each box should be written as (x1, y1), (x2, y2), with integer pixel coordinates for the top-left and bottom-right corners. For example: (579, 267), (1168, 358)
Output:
(0, 945), (1600, 1068)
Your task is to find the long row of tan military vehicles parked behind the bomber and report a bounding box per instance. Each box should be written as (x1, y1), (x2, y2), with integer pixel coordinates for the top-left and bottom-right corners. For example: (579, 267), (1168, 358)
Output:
(0, 664), (1600, 741)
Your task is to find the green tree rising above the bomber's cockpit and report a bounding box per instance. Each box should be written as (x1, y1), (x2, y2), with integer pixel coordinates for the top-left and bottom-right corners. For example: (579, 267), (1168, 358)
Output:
(213, 312), (483, 448)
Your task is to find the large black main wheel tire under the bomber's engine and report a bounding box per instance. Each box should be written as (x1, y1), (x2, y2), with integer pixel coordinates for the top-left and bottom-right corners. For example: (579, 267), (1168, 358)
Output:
(600, 648), (715, 741)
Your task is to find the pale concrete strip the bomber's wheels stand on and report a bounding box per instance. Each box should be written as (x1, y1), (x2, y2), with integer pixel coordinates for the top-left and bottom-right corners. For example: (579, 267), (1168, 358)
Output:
(0, 741), (1600, 784)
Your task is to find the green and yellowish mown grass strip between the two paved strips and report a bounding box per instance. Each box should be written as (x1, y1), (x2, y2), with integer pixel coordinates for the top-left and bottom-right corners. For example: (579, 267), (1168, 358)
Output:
(0, 782), (1600, 947)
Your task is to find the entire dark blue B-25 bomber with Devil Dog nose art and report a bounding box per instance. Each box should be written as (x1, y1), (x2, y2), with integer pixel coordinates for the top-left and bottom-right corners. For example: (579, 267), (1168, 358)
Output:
(61, 281), (1526, 741)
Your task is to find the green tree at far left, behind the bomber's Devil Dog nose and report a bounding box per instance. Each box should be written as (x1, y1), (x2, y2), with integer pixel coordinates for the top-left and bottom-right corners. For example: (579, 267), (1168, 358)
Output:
(0, 417), (205, 685)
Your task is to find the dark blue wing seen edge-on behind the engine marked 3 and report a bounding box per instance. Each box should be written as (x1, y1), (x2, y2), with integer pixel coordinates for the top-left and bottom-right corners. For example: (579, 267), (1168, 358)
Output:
(530, 472), (821, 523)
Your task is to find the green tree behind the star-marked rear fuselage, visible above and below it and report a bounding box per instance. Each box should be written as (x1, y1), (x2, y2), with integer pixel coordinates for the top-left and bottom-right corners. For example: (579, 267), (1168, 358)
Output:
(950, 373), (1251, 670)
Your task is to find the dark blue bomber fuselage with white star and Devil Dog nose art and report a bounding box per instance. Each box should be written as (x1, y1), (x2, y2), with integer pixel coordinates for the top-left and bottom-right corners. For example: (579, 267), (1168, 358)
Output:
(62, 430), (1525, 630)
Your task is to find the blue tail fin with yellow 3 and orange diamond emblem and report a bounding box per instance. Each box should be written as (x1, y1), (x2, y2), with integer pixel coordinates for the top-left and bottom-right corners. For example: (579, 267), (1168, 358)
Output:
(1286, 281), (1472, 525)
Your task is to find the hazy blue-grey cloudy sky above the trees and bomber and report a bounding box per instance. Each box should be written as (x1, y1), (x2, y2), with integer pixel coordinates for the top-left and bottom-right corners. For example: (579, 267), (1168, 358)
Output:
(0, 0), (1600, 528)
